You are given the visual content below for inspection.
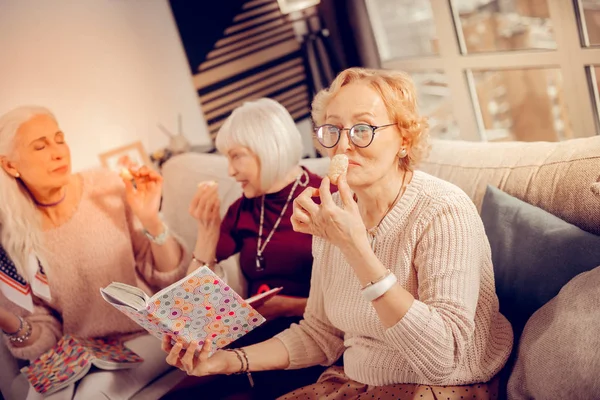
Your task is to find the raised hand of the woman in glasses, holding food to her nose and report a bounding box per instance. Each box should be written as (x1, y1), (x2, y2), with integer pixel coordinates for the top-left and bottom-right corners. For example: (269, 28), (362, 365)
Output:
(291, 174), (367, 250)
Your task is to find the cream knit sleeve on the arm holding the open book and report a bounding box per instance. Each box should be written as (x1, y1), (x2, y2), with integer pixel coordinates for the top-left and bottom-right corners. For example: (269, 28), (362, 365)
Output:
(275, 239), (344, 369)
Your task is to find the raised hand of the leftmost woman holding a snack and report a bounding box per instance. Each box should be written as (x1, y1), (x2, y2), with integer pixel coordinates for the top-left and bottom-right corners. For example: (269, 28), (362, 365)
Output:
(123, 166), (163, 228)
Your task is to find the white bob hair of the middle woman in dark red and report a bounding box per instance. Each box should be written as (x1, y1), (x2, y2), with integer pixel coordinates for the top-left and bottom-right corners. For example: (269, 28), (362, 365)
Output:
(216, 98), (303, 191)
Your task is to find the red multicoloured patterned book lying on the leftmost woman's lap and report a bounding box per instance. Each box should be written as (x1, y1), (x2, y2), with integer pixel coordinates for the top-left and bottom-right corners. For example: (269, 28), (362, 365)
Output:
(21, 335), (144, 394)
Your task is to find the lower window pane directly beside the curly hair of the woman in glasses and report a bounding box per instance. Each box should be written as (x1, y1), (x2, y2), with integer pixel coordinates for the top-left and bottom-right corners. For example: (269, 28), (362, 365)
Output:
(411, 71), (459, 139)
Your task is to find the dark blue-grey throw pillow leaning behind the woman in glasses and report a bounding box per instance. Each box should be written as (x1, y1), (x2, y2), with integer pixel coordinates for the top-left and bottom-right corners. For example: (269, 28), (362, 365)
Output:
(481, 186), (600, 342)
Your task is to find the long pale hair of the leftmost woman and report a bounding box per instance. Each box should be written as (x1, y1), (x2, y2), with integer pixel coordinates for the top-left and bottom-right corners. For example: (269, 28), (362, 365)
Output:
(0, 106), (56, 280)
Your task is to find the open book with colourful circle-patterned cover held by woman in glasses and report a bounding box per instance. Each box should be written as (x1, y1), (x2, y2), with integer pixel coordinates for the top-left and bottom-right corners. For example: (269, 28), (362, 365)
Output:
(103, 267), (265, 348)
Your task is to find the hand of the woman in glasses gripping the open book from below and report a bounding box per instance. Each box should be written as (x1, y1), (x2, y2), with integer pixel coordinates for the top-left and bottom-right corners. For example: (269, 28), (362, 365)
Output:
(162, 335), (235, 376)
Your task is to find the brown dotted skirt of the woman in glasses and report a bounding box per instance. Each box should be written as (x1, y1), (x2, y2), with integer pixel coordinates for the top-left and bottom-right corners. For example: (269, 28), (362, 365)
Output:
(278, 366), (498, 400)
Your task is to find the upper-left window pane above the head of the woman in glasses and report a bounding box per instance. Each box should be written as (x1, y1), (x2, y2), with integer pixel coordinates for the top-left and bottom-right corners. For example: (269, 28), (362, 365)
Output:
(367, 0), (438, 61)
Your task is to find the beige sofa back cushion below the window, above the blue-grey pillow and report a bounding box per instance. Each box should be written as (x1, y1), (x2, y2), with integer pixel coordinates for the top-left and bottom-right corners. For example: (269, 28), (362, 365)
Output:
(420, 136), (600, 234)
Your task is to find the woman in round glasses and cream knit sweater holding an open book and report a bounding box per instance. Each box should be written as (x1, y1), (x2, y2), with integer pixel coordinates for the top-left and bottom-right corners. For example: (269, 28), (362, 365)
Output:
(163, 68), (513, 399)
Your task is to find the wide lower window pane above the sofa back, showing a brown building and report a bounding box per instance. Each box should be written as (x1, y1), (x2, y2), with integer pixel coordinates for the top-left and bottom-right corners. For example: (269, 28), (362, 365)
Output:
(472, 68), (573, 142)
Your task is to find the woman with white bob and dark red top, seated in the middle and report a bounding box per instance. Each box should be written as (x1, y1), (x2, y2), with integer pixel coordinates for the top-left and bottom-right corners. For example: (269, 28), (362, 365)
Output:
(165, 98), (322, 399)
